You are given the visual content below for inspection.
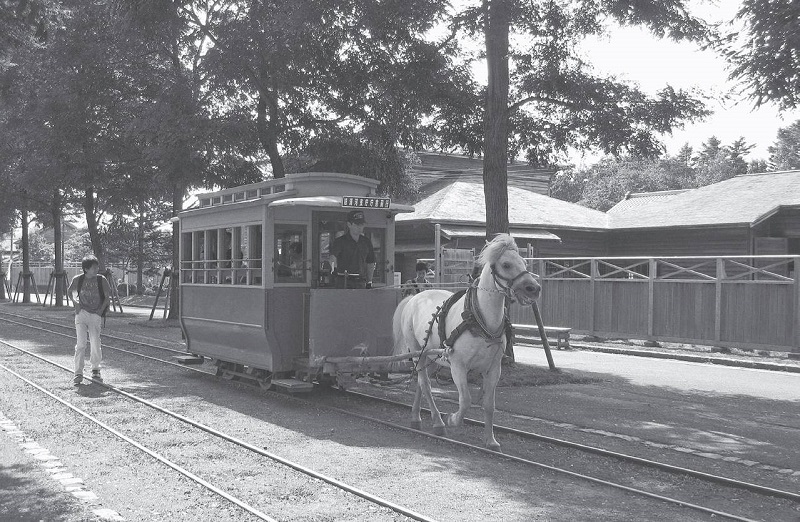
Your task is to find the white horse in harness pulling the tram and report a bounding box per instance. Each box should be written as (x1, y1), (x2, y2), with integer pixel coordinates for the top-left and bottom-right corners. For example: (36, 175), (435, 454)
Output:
(393, 234), (541, 451)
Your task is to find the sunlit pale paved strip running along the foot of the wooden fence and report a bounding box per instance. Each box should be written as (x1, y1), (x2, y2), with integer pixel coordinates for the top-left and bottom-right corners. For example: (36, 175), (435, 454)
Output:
(514, 345), (800, 401)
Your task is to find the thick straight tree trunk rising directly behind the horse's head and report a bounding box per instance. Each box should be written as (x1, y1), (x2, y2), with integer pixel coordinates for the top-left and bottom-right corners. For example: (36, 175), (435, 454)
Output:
(483, 0), (509, 239)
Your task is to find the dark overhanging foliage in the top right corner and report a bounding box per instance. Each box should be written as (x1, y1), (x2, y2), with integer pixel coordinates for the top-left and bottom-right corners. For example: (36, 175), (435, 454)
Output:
(715, 0), (800, 109)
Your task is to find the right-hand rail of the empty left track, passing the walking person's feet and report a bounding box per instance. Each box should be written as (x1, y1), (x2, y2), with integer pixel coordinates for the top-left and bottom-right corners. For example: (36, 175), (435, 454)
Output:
(0, 338), (435, 522)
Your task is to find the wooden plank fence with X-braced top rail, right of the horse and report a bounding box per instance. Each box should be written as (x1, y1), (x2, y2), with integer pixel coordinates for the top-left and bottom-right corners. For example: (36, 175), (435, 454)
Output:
(511, 256), (800, 352)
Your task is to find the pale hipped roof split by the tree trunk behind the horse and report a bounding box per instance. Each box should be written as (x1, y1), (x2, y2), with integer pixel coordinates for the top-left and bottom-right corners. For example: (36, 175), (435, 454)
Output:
(397, 181), (608, 230)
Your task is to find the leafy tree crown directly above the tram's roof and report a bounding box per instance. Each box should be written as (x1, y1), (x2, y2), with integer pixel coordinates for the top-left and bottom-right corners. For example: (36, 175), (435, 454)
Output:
(198, 0), (460, 181)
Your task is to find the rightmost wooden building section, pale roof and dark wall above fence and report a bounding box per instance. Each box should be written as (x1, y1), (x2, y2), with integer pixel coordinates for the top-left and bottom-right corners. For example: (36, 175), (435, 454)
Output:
(608, 171), (800, 257)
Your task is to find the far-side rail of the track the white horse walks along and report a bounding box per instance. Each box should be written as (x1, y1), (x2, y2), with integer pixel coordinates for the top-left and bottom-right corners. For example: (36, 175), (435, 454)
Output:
(344, 390), (800, 502)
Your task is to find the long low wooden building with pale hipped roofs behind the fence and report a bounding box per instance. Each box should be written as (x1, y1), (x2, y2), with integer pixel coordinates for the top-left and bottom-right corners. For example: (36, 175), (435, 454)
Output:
(395, 167), (800, 280)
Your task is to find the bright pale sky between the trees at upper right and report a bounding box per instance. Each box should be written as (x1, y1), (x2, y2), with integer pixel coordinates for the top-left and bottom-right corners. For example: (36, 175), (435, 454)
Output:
(579, 0), (800, 163)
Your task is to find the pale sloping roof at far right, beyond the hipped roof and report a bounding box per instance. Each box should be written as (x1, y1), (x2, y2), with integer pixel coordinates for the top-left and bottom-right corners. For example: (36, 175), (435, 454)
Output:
(608, 170), (800, 229)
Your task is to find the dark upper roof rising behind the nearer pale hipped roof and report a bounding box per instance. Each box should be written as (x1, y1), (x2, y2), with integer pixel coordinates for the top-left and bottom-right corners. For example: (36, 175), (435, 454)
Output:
(412, 151), (555, 196)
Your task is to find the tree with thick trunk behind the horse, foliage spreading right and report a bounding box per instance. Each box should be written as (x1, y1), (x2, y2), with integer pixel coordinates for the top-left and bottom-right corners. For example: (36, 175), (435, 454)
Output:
(444, 0), (708, 235)
